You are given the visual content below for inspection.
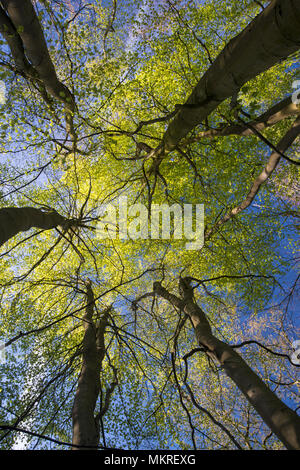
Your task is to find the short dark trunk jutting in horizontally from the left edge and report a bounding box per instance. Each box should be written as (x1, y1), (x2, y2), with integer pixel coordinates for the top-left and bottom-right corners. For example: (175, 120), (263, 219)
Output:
(0, 207), (68, 246)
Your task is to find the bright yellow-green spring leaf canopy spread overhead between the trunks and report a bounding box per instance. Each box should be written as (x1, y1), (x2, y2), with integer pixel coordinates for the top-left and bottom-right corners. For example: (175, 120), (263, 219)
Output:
(0, 0), (298, 449)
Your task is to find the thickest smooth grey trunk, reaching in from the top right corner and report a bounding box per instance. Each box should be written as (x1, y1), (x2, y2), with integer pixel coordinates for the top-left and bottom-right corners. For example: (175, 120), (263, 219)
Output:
(162, 0), (300, 154)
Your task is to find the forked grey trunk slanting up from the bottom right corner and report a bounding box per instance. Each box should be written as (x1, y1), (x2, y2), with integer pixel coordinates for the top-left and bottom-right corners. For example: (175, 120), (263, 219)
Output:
(153, 278), (300, 450)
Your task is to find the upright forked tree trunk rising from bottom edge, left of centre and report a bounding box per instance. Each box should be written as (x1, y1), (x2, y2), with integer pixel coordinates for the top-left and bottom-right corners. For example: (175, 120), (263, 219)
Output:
(72, 283), (109, 450)
